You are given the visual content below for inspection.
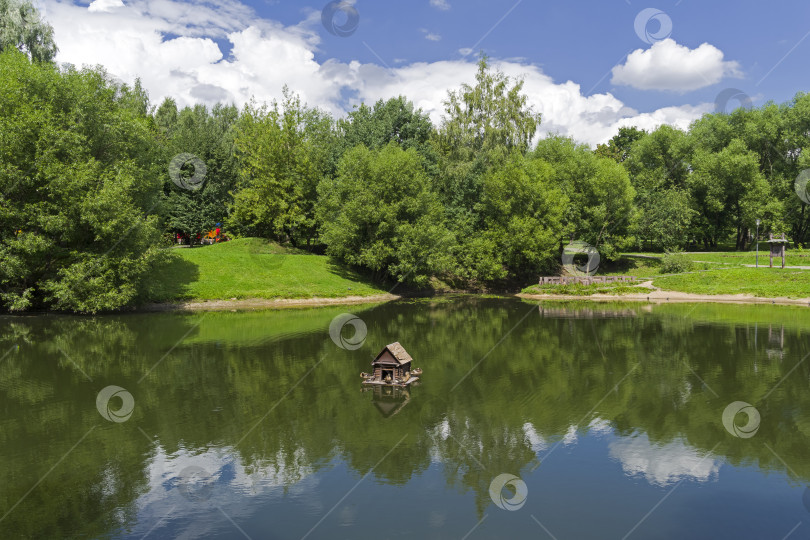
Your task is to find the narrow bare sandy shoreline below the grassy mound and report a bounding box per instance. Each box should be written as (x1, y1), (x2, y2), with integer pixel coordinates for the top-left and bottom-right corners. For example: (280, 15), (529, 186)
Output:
(144, 294), (400, 311)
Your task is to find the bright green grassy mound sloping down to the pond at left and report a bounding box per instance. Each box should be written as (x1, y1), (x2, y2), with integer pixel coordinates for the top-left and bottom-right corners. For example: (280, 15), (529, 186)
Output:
(147, 238), (387, 302)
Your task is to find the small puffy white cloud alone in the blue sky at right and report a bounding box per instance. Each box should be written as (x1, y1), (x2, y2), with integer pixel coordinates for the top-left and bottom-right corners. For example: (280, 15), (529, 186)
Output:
(611, 38), (742, 92)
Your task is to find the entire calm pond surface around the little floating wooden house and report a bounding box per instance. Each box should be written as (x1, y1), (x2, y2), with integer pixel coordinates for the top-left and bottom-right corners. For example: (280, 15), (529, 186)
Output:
(0, 298), (810, 540)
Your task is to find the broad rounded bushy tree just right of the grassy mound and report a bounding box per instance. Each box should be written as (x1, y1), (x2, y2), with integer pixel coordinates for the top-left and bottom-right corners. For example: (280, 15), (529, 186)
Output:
(318, 143), (451, 285)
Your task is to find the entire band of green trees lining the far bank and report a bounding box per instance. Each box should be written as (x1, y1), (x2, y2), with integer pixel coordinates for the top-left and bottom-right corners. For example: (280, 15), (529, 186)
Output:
(0, 3), (810, 312)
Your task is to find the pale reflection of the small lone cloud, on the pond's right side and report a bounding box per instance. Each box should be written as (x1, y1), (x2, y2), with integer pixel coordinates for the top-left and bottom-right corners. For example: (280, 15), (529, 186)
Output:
(610, 433), (720, 486)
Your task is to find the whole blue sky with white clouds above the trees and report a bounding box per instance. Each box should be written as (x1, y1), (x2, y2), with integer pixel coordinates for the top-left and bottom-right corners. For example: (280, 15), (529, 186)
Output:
(36, 0), (810, 146)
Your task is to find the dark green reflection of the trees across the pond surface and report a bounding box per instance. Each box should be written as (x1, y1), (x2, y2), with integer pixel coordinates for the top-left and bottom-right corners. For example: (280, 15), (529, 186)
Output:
(0, 300), (810, 536)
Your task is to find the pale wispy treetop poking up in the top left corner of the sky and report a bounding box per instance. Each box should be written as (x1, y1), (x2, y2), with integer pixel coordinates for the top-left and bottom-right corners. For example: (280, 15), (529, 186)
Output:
(0, 0), (58, 62)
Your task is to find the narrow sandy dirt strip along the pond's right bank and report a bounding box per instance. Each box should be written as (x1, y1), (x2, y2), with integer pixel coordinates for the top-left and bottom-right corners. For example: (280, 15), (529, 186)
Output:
(518, 283), (810, 306)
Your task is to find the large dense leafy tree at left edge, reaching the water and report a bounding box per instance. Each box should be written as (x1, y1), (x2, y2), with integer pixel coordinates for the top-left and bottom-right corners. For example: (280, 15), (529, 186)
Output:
(0, 49), (160, 312)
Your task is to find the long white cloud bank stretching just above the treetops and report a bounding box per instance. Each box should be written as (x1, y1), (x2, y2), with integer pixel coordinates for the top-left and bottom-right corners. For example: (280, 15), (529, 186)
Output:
(44, 0), (713, 145)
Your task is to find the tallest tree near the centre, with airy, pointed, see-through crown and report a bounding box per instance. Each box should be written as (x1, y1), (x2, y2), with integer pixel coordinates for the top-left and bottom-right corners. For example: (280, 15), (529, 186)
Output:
(434, 56), (541, 283)
